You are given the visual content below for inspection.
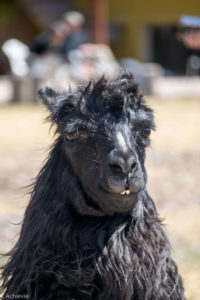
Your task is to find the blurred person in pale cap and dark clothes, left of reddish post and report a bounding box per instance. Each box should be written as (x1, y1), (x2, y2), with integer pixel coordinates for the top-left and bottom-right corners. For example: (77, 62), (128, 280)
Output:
(29, 11), (87, 80)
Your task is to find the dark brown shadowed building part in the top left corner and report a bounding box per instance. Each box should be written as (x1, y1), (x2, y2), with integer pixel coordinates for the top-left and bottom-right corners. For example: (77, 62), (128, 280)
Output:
(0, 0), (78, 74)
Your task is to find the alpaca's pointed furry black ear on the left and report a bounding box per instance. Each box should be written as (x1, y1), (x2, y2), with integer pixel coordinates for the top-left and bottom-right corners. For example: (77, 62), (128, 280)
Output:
(38, 87), (65, 122)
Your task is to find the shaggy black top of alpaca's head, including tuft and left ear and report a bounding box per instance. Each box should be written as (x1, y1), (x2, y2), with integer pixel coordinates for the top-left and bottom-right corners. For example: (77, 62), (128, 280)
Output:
(38, 72), (145, 123)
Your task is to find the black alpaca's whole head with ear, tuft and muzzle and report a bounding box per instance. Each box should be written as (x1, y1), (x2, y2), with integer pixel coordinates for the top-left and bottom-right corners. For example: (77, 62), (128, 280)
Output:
(39, 73), (154, 214)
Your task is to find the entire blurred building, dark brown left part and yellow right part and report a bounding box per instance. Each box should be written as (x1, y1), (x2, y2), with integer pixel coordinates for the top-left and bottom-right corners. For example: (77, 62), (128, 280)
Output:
(0, 0), (200, 75)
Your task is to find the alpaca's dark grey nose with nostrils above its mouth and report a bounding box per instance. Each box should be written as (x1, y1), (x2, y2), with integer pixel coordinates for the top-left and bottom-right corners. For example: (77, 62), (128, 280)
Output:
(108, 154), (137, 175)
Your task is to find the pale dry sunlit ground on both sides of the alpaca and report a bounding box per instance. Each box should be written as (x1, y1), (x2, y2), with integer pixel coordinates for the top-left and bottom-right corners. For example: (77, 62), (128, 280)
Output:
(0, 99), (200, 300)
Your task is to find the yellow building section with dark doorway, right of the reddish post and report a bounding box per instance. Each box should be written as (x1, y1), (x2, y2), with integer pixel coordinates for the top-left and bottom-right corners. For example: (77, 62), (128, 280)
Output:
(77, 0), (200, 75)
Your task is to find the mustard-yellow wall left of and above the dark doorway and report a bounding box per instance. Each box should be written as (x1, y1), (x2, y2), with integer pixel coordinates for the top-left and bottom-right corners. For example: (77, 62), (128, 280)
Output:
(76, 0), (200, 61)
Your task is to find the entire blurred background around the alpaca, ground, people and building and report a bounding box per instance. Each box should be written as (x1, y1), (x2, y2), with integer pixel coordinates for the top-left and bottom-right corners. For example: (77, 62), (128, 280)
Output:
(0, 0), (200, 300)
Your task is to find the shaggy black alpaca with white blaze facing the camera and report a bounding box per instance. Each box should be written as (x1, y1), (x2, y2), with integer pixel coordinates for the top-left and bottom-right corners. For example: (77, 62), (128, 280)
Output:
(2, 73), (185, 300)
